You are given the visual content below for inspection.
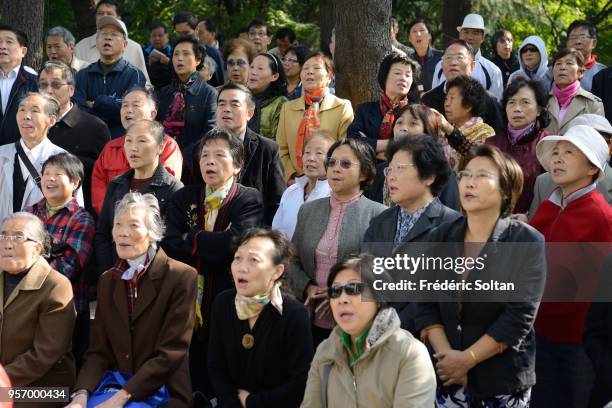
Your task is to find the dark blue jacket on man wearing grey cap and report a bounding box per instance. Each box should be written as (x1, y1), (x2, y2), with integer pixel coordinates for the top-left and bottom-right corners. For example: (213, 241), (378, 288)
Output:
(73, 58), (146, 138)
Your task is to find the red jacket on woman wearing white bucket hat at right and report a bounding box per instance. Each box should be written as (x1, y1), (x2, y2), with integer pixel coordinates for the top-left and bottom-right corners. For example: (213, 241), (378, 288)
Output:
(530, 190), (612, 344)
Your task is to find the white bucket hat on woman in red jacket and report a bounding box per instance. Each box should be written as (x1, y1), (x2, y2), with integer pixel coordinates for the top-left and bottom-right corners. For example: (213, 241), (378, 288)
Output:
(536, 125), (610, 181)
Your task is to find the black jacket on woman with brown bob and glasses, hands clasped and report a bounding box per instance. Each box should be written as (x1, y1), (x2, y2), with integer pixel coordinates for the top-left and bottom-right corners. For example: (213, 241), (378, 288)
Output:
(416, 218), (546, 398)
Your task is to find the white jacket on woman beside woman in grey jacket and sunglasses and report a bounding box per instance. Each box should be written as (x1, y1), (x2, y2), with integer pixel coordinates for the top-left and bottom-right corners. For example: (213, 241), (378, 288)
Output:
(272, 176), (331, 239)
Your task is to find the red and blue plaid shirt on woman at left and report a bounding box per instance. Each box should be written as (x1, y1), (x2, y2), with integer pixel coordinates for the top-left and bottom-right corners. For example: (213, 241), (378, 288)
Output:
(25, 198), (95, 312)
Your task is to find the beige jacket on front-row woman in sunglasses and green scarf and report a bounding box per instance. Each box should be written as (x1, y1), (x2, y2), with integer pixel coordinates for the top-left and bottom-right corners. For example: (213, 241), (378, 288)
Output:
(301, 308), (436, 408)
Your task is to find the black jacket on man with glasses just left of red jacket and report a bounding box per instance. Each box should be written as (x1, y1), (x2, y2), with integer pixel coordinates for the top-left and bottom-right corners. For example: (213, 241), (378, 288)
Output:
(49, 104), (111, 214)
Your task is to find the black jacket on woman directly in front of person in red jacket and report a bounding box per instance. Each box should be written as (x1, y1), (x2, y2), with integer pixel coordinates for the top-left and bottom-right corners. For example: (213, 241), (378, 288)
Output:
(94, 163), (183, 273)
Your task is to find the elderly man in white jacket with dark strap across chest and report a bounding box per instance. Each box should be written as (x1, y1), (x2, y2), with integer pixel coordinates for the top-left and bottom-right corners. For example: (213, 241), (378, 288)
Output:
(0, 93), (83, 219)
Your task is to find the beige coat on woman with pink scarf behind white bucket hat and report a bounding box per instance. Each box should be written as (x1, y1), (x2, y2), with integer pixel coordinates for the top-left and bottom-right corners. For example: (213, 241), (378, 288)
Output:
(546, 88), (604, 135)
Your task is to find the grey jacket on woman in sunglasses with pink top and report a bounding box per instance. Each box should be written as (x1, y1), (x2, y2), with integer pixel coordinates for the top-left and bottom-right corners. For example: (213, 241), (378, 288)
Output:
(287, 196), (387, 300)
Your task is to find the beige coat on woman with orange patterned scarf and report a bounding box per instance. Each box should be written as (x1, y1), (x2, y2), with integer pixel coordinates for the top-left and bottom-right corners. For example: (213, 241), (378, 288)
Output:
(276, 93), (354, 181)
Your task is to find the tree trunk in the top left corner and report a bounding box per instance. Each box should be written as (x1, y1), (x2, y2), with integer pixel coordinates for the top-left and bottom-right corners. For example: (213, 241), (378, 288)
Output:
(2, 0), (45, 70)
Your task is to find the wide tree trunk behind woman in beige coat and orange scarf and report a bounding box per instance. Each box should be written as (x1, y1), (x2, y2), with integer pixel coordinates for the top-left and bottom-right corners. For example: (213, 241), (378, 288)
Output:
(334, 0), (391, 107)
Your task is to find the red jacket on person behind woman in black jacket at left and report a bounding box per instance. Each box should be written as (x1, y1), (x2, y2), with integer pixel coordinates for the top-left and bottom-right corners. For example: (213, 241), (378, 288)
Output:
(91, 136), (183, 214)
